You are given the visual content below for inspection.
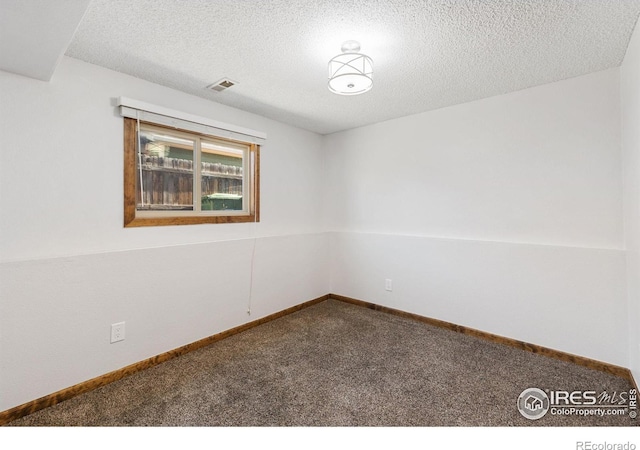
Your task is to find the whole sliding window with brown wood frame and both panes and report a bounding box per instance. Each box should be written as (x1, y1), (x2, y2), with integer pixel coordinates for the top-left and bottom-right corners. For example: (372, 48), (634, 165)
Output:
(124, 118), (260, 227)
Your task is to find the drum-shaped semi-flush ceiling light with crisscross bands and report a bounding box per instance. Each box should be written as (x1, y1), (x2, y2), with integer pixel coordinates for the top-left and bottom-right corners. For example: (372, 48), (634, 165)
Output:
(329, 41), (373, 95)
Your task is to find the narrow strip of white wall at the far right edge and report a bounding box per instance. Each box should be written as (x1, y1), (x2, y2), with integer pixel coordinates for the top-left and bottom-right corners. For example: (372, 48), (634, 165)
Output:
(620, 21), (640, 383)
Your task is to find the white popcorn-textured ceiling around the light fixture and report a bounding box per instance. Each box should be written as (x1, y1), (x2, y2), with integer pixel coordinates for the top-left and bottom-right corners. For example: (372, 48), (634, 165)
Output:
(61, 0), (640, 134)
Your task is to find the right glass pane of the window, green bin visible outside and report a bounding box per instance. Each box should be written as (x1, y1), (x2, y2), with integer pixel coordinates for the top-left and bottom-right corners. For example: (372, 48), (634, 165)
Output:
(201, 140), (248, 211)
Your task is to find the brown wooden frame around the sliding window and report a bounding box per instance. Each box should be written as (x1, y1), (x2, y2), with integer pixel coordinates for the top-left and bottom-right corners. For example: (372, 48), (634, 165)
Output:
(124, 117), (260, 227)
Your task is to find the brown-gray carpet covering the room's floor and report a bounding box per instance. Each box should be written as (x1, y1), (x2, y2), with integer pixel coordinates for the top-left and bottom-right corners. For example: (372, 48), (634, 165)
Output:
(9, 300), (640, 427)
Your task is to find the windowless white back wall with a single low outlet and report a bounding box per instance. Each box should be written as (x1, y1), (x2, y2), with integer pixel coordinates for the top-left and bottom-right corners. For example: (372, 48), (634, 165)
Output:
(325, 69), (628, 366)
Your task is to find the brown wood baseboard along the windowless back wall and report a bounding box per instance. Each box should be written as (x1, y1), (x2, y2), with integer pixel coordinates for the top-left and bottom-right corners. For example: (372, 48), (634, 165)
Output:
(329, 294), (637, 384)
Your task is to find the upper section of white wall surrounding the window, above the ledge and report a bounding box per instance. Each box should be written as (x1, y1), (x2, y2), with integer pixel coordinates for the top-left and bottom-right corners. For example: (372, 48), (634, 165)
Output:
(0, 58), (323, 261)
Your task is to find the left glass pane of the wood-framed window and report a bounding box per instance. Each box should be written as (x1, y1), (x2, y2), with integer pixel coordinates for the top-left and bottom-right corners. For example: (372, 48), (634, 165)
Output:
(136, 129), (195, 211)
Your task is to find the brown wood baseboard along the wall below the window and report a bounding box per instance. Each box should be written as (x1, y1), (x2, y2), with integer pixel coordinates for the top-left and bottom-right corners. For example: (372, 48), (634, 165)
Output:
(0, 295), (329, 425)
